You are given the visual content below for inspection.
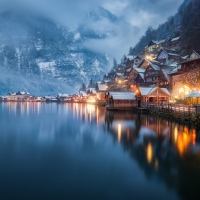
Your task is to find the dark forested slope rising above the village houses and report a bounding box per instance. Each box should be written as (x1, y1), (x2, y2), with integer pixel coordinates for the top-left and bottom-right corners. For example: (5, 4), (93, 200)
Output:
(129, 0), (200, 55)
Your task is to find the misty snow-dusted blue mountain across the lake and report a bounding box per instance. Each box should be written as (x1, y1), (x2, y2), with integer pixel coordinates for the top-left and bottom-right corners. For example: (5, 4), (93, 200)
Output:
(0, 7), (137, 95)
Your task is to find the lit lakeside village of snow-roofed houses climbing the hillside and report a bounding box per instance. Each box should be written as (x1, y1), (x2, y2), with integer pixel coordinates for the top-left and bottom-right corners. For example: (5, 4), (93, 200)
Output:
(0, 37), (200, 115)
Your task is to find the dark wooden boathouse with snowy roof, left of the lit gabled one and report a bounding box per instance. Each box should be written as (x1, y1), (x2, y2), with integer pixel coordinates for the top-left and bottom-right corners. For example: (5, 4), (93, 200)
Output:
(105, 92), (136, 110)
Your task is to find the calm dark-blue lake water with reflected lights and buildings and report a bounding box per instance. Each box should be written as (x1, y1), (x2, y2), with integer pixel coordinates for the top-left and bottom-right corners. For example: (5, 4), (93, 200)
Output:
(0, 103), (200, 200)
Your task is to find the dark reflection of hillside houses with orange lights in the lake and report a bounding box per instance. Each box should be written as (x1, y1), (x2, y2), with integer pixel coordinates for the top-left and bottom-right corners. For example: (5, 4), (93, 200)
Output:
(105, 111), (200, 199)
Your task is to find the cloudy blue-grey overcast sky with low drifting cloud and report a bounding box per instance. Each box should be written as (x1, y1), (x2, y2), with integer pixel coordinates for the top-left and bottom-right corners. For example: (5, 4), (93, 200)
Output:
(0, 0), (183, 57)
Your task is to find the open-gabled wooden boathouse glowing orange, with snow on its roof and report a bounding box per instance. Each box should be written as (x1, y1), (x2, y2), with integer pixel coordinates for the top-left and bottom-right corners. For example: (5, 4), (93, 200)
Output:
(136, 87), (170, 107)
